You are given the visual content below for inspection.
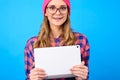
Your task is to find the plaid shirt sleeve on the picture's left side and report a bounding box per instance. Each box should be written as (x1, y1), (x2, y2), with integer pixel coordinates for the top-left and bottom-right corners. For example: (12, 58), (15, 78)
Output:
(24, 40), (34, 80)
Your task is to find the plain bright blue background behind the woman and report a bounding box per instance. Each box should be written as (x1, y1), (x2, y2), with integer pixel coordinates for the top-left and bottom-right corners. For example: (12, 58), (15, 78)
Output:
(0, 0), (120, 80)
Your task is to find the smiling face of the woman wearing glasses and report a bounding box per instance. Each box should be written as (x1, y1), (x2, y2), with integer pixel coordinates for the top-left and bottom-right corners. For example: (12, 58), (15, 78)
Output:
(45, 0), (68, 26)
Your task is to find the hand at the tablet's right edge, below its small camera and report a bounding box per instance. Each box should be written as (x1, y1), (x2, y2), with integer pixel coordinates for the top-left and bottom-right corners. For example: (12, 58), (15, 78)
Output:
(71, 61), (88, 80)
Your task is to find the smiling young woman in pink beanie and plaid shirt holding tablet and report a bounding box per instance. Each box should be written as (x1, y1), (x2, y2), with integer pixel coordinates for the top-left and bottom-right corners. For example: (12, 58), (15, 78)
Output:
(24, 0), (89, 80)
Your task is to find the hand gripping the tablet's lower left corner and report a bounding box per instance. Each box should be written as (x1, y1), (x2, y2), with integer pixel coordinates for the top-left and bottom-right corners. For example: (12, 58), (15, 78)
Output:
(29, 68), (47, 80)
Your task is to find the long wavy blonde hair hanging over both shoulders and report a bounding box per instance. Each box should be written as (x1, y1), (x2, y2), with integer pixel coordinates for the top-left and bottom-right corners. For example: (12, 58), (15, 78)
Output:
(33, 15), (76, 48)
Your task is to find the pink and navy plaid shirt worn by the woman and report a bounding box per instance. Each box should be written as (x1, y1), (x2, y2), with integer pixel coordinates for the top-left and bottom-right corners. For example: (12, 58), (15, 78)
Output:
(24, 32), (90, 80)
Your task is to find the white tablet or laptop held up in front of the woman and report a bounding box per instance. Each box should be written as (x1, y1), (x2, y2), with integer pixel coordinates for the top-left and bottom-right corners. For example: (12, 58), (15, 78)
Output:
(34, 45), (81, 79)
